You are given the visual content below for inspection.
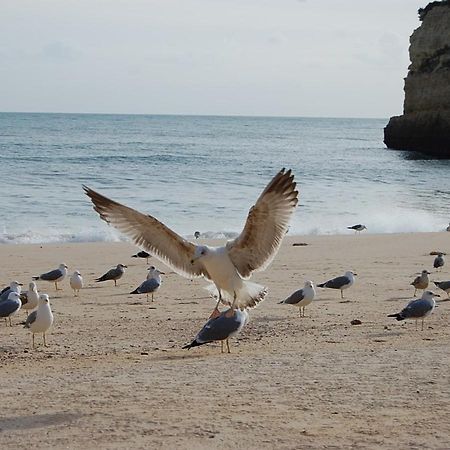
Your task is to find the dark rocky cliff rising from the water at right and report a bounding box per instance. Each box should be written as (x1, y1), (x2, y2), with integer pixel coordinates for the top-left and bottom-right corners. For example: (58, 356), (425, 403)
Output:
(384, 1), (450, 158)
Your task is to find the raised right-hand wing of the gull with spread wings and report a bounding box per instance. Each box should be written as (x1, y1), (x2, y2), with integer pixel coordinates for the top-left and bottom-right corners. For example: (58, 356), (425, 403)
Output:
(227, 169), (298, 278)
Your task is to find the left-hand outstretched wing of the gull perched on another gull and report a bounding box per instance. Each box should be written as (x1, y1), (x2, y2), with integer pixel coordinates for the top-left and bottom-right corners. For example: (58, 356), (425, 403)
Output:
(83, 186), (206, 278)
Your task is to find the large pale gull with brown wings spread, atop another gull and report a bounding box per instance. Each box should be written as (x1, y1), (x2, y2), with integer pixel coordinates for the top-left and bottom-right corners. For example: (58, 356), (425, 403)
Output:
(83, 169), (298, 309)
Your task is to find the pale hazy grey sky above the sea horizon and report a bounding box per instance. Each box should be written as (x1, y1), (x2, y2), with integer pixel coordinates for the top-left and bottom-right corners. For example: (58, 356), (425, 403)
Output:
(0, 0), (428, 118)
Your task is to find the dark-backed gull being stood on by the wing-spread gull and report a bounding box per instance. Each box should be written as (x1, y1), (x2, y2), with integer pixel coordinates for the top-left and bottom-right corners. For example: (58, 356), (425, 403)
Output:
(183, 308), (248, 353)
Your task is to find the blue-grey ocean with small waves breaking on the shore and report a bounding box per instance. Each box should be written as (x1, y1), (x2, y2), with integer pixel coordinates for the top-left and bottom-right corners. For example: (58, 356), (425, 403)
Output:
(0, 113), (450, 244)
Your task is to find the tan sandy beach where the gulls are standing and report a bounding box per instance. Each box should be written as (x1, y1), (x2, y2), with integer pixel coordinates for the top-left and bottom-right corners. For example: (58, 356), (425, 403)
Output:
(0, 232), (450, 449)
